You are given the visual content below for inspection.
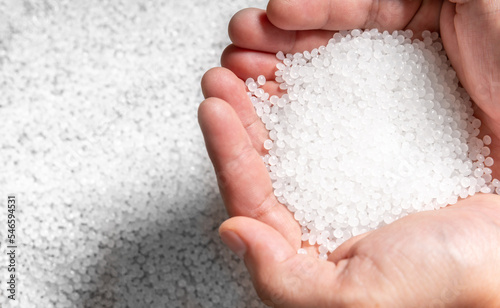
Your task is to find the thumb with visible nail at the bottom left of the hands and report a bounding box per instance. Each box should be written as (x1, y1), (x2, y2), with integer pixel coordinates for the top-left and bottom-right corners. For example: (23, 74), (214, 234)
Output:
(219, 217), (350, 307)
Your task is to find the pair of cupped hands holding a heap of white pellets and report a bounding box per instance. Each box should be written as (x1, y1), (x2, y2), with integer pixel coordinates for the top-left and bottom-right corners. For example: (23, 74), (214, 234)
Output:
(199, 0), (500, 307)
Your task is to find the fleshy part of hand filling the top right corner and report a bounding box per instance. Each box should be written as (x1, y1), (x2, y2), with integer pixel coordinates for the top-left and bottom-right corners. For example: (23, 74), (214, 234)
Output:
(443, 0), (500, 115)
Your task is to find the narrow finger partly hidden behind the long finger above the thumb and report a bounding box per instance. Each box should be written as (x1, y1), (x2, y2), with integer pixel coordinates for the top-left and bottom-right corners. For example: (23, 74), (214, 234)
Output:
(201, 67), (268, 155)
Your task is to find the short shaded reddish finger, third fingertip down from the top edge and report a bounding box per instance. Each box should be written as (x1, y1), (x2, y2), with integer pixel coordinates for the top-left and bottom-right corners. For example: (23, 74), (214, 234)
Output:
(221, 45), (279, 80)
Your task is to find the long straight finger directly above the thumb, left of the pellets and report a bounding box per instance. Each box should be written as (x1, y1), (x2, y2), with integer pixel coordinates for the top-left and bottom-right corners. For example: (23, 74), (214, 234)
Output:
(198, 98), (300, 247)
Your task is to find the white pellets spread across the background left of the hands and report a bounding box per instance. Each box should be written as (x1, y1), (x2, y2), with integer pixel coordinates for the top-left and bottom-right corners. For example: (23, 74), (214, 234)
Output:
(0, 0), (267, 308)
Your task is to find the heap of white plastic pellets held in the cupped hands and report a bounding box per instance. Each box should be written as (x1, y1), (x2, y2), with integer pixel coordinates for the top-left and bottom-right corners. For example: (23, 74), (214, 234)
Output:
(246, 29), (498, 259)
